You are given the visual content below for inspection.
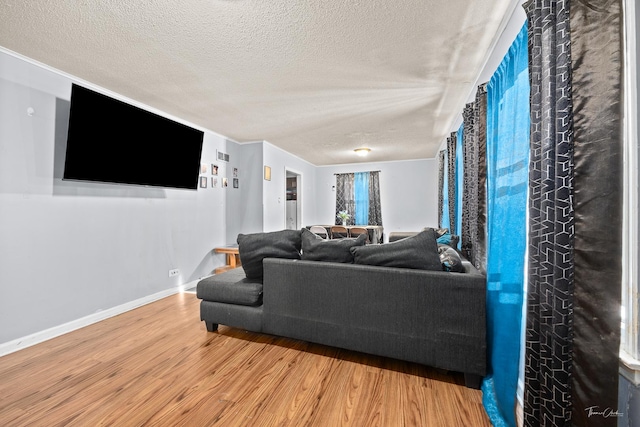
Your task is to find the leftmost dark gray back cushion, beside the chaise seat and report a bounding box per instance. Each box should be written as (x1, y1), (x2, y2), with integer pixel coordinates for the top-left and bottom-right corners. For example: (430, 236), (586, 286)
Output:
(237, 230), (302, 280)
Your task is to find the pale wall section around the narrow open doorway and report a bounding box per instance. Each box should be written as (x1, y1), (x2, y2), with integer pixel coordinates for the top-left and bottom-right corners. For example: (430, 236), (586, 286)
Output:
(263, 141), (320, 231)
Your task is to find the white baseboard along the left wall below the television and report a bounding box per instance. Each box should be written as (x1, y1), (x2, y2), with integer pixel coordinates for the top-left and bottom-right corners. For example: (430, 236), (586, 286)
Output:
(0, 283), (181, 357)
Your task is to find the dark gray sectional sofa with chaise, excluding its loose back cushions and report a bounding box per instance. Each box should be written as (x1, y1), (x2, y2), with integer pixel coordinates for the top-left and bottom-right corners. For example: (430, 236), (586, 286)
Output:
(197, 229), (486, 388)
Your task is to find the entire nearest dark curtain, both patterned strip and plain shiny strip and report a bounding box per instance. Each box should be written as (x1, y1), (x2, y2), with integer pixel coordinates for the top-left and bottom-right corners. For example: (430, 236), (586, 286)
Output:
(524, 0), (623, 426)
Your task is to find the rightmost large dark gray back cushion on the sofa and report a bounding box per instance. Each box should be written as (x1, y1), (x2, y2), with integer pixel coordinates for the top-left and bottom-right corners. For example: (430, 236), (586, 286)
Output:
(351, 228), (442, 271)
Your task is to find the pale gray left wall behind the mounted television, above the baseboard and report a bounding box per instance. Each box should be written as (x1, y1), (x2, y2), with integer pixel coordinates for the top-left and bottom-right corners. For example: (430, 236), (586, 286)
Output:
(0, 52), (227, 344)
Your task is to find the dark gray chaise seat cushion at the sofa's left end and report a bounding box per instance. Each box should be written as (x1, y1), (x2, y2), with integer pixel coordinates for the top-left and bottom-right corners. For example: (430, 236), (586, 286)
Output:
(196, 268), (262, 306)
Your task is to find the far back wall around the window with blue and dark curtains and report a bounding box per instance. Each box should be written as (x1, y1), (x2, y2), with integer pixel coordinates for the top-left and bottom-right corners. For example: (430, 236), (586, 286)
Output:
(315, 159), (438, 241)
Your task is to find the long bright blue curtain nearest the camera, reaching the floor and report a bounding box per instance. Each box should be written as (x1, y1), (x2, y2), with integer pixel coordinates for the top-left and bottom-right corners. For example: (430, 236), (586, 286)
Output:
(482, 23), (530, 426)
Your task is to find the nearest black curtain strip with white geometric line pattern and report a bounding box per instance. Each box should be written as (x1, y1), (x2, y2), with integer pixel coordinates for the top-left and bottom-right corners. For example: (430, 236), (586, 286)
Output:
(524, 0), (575, 427)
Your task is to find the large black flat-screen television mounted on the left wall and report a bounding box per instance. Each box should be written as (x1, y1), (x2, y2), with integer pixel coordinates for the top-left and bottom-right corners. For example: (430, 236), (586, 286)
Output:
(63, 84), (204, 190)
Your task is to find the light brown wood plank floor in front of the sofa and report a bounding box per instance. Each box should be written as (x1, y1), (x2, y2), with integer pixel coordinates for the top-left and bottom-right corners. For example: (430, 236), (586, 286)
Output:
(0, 293), (490, 427)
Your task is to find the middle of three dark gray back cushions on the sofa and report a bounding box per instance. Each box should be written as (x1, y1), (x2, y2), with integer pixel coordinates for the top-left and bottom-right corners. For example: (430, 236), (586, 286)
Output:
(302, 229), (367, 263)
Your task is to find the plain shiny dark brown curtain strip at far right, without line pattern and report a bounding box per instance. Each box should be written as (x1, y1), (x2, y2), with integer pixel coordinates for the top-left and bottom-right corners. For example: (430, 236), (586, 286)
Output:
(559, 0), (624, 426)
